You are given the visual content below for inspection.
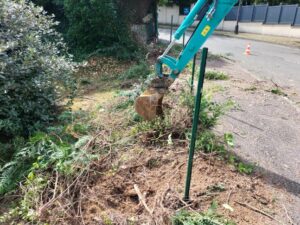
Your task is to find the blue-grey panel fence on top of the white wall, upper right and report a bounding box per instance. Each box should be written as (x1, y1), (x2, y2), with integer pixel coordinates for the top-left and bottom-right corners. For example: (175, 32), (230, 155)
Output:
(225, 5), (300, 26)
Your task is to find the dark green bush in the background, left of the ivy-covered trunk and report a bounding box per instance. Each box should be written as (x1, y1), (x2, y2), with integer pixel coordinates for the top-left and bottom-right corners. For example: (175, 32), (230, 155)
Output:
(64, 0), (138, 59)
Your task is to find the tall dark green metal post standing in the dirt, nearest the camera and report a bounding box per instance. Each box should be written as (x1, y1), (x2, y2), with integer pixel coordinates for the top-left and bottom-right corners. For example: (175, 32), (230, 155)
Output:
(184, 48), (208, 201)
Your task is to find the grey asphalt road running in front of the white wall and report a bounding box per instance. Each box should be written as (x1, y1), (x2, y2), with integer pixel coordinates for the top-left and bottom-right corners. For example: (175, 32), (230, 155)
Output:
(159, 29), (300, 90)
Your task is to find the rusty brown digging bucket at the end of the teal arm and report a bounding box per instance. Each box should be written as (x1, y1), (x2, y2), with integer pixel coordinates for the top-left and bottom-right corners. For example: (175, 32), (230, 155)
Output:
(135, 77), (173, 120)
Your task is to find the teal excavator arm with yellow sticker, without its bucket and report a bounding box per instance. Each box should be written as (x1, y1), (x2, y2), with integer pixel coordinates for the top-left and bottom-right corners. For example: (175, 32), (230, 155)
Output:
(156, 0), (237, 79)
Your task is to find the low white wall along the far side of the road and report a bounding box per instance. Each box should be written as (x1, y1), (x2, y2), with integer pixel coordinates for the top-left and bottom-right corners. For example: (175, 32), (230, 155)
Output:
(158, 5), (300, 38)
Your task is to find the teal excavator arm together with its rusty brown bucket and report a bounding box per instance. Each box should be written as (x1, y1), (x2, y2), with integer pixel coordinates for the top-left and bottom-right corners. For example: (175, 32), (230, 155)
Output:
(135, 0), (237, 120)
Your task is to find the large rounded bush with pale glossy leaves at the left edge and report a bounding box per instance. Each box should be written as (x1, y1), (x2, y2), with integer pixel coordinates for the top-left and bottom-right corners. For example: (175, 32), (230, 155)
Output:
(0, 0), (74, 140)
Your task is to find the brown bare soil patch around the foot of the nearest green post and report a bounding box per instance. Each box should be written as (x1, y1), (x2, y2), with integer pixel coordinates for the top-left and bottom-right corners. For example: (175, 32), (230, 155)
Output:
(82, 147), (285, 225)
